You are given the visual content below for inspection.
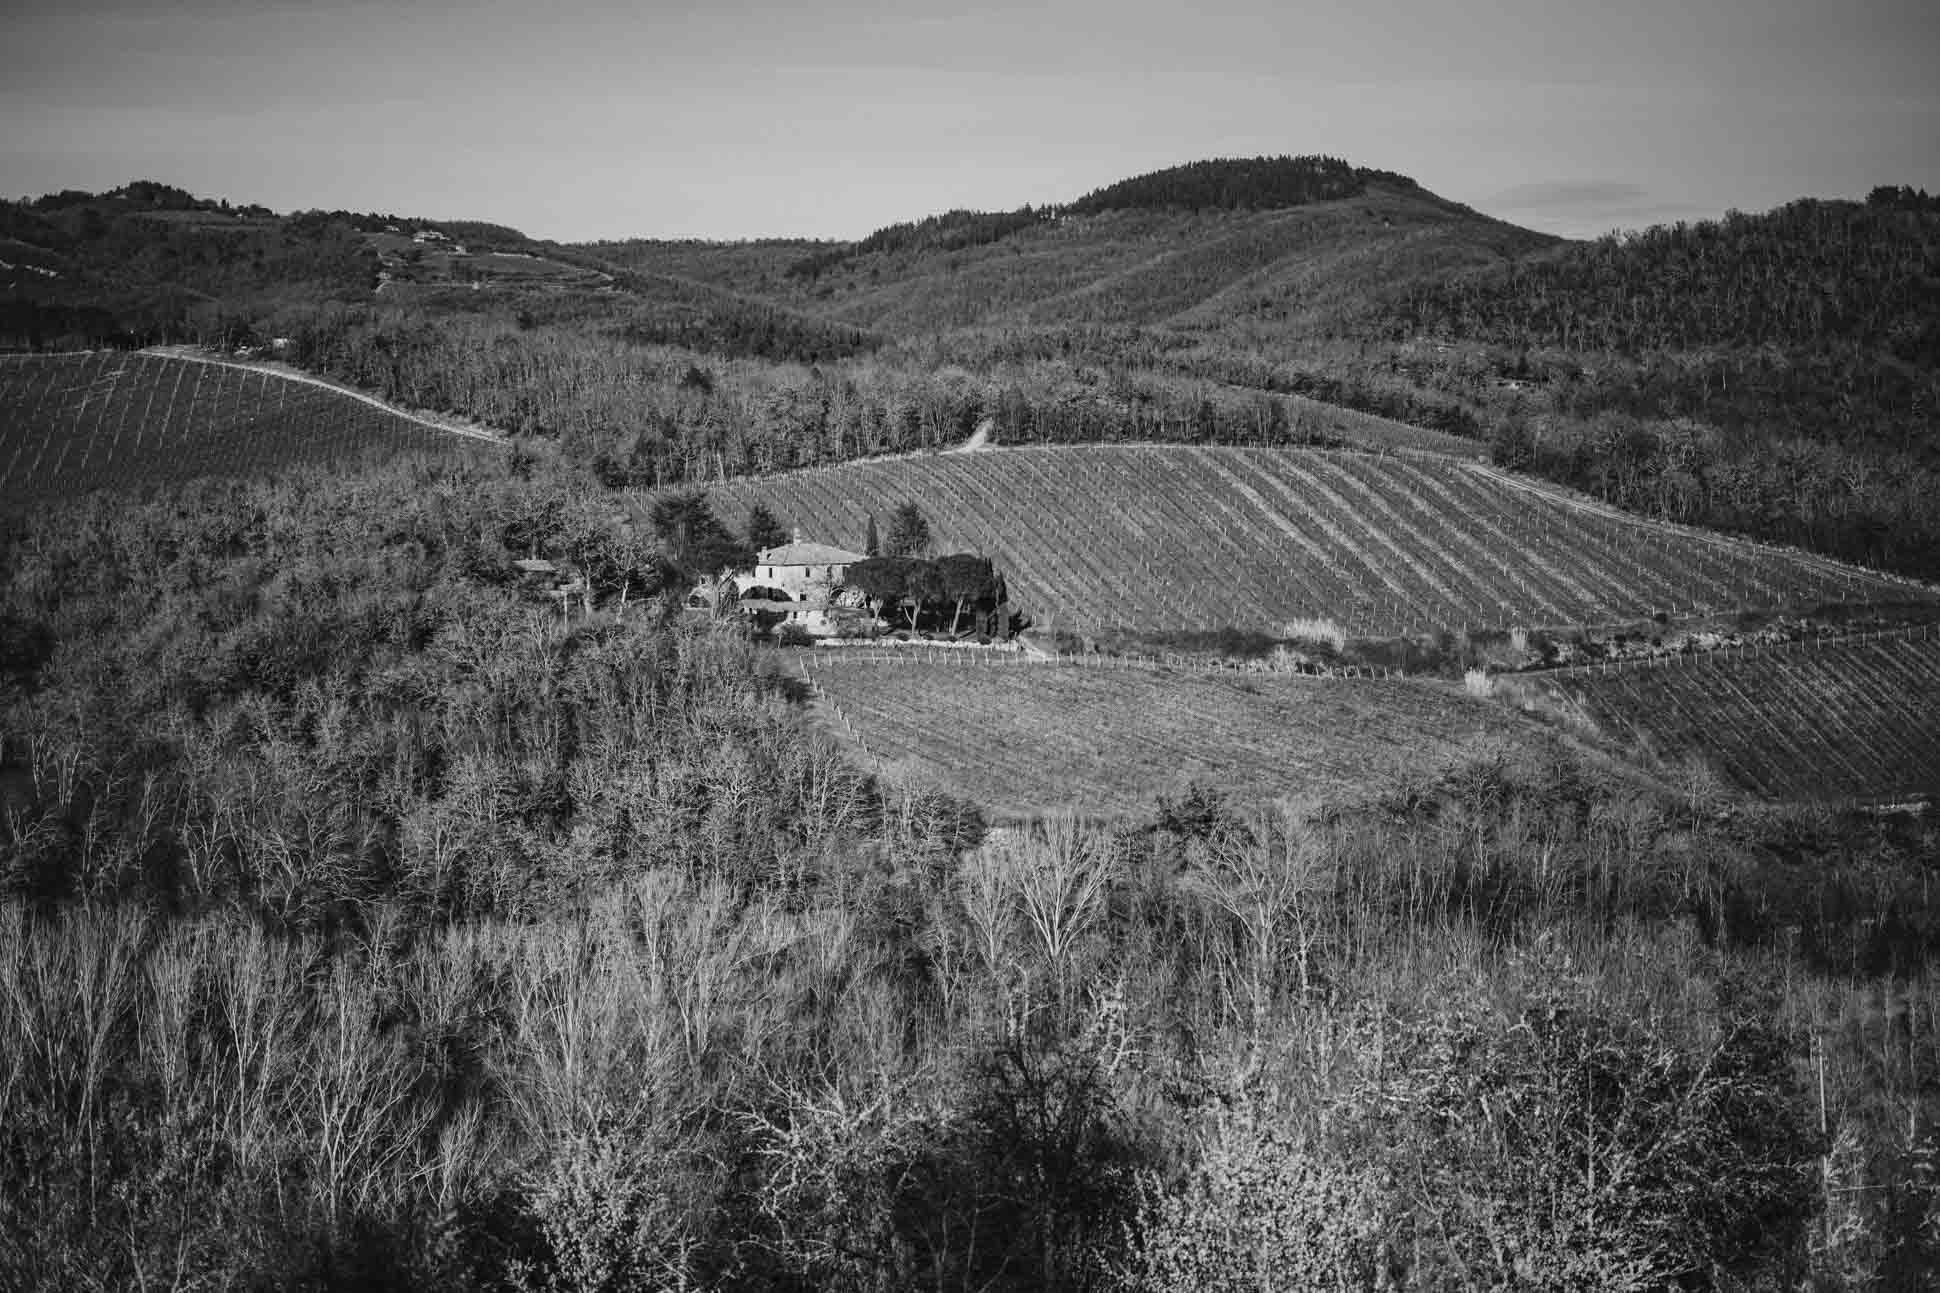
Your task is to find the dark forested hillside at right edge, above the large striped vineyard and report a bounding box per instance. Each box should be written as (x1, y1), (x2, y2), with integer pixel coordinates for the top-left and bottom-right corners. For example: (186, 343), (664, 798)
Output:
(1339, 188), (1940, 579)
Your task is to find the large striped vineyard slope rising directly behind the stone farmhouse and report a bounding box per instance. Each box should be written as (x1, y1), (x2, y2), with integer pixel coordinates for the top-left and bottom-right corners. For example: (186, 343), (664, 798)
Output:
(710, 445), (1932, 637)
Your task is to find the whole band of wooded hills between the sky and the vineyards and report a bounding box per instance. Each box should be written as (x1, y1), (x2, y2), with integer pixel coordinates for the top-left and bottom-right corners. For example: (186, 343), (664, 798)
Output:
(15, 157), (1940, 579)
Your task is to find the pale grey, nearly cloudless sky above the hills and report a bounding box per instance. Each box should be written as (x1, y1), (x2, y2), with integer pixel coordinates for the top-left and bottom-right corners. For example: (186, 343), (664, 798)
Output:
(0, 0), (1940, 241)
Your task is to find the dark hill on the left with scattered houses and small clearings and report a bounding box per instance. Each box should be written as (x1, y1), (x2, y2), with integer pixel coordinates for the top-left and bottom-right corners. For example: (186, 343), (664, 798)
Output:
(0, 181), (873, 366)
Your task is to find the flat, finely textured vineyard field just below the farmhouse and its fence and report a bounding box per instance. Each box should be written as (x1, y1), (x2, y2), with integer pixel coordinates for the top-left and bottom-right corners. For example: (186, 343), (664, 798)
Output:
(801, 652), (1531, 817)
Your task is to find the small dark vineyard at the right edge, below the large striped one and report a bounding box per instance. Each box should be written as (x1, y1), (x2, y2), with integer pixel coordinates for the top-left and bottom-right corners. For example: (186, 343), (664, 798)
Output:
(1531, 627), (1940, 802)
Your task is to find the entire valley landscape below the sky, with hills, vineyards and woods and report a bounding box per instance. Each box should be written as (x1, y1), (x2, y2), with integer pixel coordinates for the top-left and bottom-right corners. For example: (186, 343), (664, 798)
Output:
(0, 156), (1940, 1293)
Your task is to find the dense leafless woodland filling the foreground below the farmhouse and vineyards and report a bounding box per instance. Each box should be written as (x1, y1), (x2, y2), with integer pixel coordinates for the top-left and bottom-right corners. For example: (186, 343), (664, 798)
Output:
(0, 460), (1940, 1289)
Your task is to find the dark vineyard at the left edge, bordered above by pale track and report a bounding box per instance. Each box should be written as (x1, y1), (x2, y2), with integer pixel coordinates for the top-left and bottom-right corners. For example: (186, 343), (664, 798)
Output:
(0, 351), (481, 505)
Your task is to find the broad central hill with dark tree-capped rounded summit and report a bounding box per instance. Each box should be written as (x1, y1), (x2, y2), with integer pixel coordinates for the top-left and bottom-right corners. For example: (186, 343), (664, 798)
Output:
(599, 157), (1554, 336)
